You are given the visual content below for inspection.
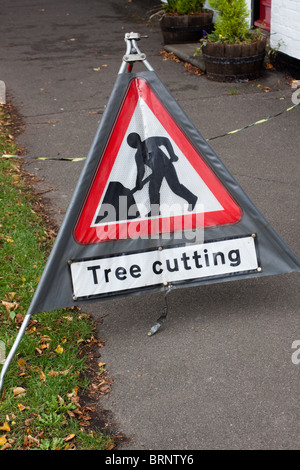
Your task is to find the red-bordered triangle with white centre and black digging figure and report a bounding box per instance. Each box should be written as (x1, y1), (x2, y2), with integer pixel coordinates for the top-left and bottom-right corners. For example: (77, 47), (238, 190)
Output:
(74, 77), (241, 244)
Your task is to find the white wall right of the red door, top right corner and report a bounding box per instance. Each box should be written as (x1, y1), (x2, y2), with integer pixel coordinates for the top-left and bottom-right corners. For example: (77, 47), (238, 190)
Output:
(270, 0), (300, 59)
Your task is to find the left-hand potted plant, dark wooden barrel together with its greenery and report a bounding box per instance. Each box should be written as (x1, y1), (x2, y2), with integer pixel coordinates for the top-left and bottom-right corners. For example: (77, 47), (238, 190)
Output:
(159, 0), (213, 44)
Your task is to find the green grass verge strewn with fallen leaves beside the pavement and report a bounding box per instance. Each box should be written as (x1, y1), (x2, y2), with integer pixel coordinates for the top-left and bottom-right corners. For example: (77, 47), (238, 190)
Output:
(0, 105), (113, 450)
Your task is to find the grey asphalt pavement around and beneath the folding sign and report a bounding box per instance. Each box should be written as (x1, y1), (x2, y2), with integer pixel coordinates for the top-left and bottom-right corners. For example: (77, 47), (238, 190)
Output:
(0, 0), (300, 450)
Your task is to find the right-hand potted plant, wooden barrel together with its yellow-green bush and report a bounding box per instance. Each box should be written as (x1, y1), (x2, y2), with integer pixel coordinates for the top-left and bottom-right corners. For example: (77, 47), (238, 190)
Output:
(202, 0), (266, 81)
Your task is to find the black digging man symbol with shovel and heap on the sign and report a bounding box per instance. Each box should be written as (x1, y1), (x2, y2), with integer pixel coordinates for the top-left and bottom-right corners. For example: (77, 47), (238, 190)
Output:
(96, 132), (198, 223)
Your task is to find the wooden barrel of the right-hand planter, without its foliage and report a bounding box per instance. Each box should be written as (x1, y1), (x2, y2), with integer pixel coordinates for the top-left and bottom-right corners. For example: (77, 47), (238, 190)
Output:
(202, 39), (266, 82)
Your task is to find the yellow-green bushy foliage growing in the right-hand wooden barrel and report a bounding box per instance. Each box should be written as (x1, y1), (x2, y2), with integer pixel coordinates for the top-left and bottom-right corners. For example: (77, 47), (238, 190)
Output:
(208, 0), (250, 43)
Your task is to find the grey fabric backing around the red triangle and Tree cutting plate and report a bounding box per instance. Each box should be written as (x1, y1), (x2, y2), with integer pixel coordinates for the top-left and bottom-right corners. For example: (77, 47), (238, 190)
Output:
(26, 71), (300, 313)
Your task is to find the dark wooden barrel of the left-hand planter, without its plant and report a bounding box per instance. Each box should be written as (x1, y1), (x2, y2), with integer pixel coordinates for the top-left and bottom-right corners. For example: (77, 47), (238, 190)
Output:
(160, 10), (213, 44)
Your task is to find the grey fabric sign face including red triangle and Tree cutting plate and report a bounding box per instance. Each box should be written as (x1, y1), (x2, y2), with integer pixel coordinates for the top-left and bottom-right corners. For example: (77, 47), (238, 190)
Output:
(19, 71), (300, 313)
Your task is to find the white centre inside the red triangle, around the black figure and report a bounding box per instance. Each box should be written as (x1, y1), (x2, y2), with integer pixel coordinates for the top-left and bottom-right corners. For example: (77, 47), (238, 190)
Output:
(91, 98), (224, 227)
